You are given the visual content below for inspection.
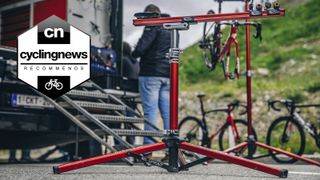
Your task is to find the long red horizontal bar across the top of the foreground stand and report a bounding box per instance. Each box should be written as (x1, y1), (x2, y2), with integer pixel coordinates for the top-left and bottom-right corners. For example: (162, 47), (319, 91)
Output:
(133, 10), (285, 26)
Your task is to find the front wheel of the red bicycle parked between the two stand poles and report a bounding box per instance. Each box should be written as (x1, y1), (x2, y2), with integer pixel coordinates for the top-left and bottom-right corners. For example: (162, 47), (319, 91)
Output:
(219, 119), (258, 156)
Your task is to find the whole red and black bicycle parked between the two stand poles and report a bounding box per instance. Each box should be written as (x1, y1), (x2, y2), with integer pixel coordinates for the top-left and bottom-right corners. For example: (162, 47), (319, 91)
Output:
(179, 94), (257, 153)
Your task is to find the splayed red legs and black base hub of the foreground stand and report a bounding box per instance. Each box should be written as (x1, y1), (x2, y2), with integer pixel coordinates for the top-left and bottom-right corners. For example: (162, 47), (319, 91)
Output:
(53, 136), (288, 178)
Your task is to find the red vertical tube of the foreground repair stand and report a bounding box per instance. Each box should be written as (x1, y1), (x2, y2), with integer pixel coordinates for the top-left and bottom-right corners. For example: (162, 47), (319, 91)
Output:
(170, 59), (179, 130)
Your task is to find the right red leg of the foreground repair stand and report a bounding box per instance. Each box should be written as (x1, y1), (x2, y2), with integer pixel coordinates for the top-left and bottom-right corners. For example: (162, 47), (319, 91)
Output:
(180, 142), (288, 177)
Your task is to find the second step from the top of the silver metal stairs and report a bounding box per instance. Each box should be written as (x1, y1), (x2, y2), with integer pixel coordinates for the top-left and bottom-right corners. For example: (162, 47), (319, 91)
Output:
(73, 101), (126, 111)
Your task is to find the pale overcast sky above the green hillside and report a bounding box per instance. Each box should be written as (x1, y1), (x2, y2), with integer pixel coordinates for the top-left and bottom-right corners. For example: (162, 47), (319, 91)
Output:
(123, 0), (244, 48)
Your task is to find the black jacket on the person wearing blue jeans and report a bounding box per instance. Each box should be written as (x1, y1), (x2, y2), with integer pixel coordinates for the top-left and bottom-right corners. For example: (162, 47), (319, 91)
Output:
(132, 26), (171, 77)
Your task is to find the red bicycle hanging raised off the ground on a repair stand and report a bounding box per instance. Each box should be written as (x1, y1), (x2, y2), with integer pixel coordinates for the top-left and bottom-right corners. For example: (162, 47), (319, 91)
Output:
(199, 10), (262, 80)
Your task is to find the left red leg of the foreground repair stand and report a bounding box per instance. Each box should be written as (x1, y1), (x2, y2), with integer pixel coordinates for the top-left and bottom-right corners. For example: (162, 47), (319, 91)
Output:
(53, 142), (166, 174)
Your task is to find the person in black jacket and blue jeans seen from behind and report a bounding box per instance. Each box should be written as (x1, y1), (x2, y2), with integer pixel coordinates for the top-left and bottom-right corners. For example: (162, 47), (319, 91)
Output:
(132, 4), (171, 144)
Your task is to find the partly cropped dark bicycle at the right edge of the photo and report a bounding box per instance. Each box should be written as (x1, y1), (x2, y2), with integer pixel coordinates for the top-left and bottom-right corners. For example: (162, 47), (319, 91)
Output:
(267, 99), (320, 163)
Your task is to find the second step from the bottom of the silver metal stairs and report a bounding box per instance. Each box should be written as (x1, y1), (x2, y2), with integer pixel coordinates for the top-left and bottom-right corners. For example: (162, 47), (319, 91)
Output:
(77, 114), (145, 123)
